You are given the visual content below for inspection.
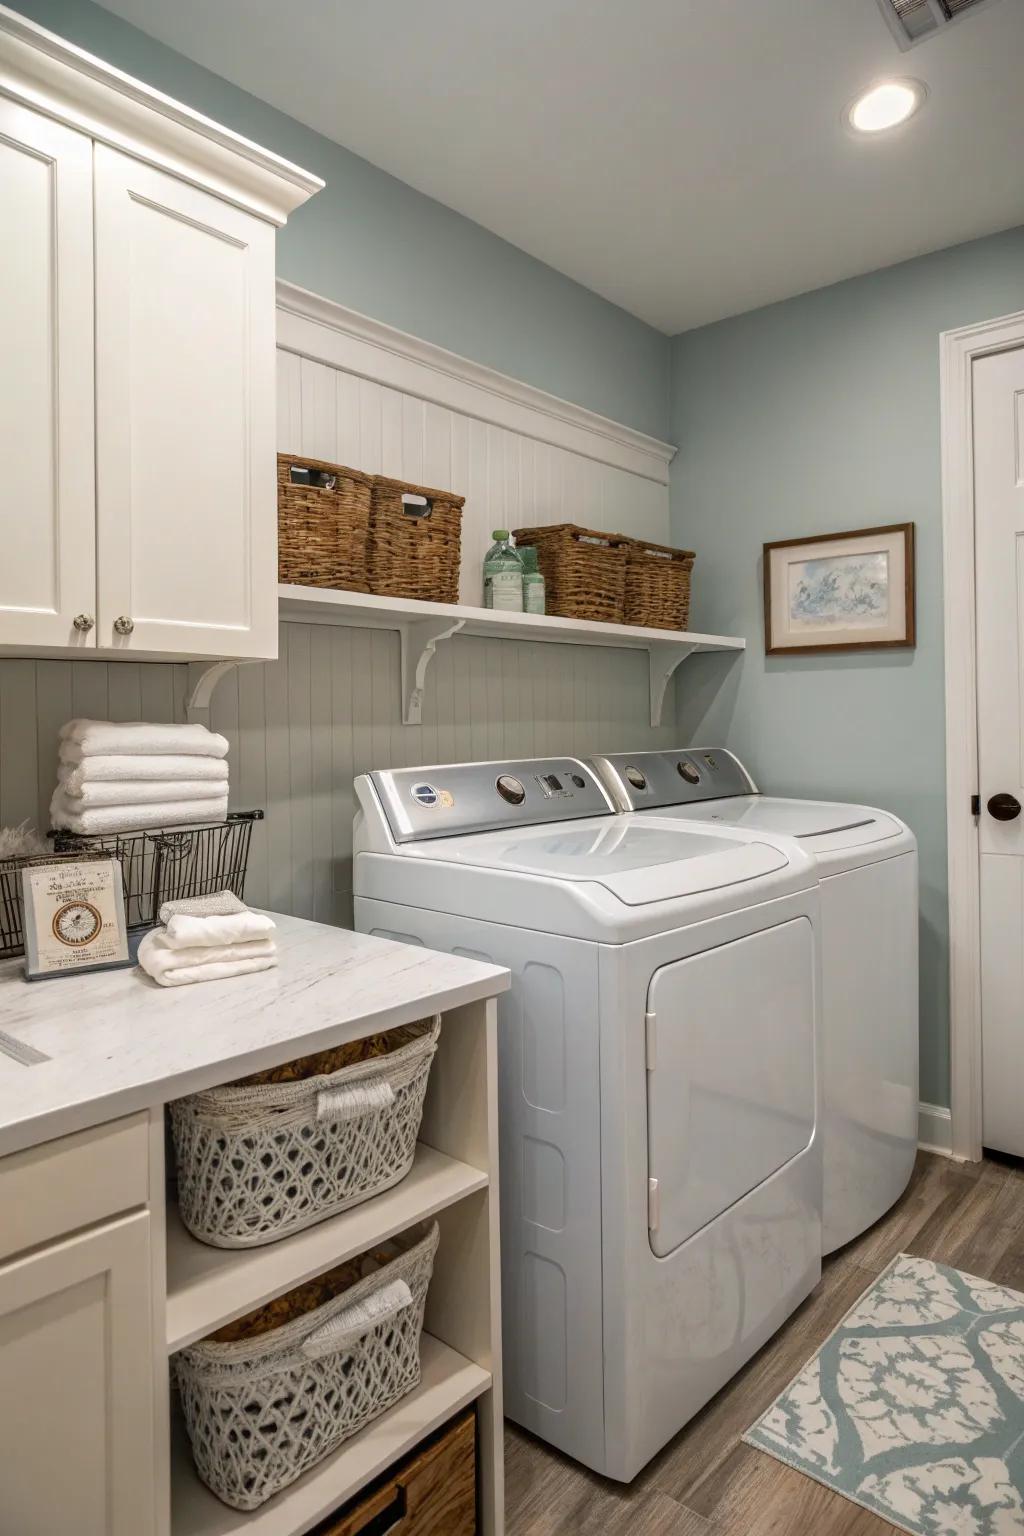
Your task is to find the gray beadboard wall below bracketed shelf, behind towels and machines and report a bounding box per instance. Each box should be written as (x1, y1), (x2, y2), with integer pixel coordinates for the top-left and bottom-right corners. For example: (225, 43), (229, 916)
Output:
(0, 624), (677, 926)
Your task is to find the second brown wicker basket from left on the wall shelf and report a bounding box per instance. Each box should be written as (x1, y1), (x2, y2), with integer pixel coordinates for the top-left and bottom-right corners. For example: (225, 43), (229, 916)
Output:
(368, 475), (465, 602)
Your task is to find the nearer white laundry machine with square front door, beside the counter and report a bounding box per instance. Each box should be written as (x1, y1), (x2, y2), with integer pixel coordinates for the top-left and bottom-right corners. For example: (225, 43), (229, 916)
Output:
(355, 759), (821, 1481)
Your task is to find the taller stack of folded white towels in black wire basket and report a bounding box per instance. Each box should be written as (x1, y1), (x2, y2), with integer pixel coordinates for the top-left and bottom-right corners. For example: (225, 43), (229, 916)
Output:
(49, 720), (227, 834)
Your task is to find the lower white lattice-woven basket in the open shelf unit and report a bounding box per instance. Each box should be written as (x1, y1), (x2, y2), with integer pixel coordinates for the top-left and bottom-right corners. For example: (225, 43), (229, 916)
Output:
(175, 1223), (439, 1510)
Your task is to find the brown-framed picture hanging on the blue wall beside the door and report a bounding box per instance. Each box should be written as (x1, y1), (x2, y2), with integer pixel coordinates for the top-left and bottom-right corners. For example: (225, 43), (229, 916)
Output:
(765, 522), (913, 656)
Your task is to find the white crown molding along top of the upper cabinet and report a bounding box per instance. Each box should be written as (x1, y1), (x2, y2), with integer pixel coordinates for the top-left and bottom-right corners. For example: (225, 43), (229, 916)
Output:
(0, 6), (324, 224)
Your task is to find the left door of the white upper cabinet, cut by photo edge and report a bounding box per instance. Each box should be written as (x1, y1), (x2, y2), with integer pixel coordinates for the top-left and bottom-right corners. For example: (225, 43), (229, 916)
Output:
(0, 98), (97, 650)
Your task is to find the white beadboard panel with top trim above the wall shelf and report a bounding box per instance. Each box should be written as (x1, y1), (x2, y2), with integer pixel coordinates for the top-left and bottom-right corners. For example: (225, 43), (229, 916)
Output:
(278, 283), (676, 605)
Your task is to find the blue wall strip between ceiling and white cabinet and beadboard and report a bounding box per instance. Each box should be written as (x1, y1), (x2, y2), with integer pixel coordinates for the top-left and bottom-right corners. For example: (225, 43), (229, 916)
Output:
(15, 0), (669, 438)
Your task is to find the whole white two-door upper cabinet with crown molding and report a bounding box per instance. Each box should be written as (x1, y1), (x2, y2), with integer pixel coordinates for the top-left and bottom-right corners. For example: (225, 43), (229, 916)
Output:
(0, 6), (322, 657)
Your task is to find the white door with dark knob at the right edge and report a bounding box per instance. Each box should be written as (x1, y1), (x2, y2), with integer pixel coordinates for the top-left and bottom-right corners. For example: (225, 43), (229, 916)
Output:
(973, 349), (1024, 1157)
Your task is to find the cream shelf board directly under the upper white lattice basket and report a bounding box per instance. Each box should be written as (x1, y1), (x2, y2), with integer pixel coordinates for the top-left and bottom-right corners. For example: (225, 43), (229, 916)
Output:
(167, 1141), (487, 1353)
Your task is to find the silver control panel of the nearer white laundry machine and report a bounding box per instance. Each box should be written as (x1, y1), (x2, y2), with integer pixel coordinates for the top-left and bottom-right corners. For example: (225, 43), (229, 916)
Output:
(370, 757), (614, 843)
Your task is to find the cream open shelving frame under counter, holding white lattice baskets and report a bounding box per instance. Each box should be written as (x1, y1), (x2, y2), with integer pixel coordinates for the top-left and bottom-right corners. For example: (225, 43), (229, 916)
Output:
(161, 998), (504, 1536)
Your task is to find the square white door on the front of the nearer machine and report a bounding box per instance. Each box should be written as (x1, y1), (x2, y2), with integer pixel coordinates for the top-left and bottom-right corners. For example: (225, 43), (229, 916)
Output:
(648, 917), (815, 1258)
